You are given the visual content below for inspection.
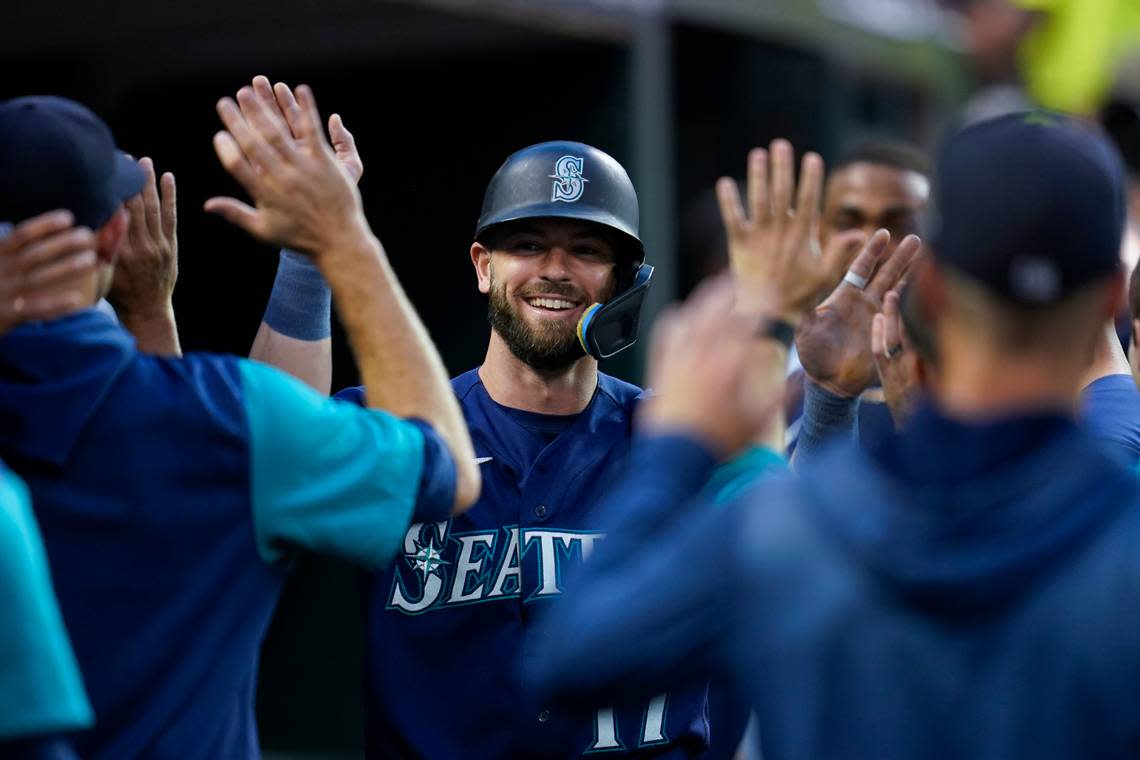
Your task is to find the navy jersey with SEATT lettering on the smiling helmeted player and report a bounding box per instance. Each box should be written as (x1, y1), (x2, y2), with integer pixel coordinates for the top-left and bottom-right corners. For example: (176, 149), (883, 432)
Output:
(340, 370), (709, 758)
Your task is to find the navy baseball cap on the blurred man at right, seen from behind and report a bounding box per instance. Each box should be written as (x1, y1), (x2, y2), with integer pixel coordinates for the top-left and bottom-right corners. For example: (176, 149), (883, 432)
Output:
(929, 112), (1126, 305)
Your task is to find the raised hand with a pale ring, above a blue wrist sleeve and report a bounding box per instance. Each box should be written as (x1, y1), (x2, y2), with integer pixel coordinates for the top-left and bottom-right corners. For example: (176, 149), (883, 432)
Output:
(796, 230), (922, 398)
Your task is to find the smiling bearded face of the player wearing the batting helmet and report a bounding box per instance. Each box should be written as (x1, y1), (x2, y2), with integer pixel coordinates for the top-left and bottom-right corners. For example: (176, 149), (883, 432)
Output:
(475, 219), (617, 370)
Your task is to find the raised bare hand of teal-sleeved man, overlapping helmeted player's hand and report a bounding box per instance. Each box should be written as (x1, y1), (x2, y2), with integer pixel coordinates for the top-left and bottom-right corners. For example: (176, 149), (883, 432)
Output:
(205, 84), (371, 257)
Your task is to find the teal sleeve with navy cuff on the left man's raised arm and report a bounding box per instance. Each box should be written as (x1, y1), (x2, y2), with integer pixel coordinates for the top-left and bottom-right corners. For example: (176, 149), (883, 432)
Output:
(241, 361), (456, 569)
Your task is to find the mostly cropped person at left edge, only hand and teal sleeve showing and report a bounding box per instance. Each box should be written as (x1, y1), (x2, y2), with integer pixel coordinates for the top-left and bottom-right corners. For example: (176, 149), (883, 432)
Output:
(0, 211), (96, 760)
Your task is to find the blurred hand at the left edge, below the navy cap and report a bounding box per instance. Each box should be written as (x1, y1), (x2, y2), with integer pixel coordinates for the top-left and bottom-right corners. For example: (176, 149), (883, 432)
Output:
(0, 211), (98, 335)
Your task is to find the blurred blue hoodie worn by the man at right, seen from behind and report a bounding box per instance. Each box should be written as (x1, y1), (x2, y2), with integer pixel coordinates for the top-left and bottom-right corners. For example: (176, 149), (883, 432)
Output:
(530, 408), (1140, 760)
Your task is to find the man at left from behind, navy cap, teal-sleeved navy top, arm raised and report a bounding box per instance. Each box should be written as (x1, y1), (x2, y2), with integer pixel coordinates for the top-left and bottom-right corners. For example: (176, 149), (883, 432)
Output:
(0, 89), (479, 760)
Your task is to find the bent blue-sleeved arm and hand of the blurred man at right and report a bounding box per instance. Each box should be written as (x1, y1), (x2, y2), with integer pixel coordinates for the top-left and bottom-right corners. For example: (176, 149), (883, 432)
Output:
(528, 280), (783, 703)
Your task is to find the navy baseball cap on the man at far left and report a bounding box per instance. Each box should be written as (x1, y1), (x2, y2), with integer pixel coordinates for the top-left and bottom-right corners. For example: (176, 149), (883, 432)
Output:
(0, 96), (145, 229)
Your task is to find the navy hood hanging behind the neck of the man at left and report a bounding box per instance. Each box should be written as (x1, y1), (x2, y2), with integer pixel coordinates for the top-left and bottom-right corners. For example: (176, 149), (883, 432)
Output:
(0, 309), (136, 467)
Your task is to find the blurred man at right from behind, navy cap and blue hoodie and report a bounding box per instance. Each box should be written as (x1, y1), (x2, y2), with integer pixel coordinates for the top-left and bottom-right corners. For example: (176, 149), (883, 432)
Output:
(535, 114), (1140, 760)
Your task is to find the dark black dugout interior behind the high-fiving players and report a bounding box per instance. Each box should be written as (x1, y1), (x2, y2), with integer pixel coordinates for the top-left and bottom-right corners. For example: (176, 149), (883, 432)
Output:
(0, 0), (953, 757)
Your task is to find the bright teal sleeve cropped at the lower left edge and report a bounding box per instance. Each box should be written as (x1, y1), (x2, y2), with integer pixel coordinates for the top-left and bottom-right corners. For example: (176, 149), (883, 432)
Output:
(0, 466), (93, 739)
